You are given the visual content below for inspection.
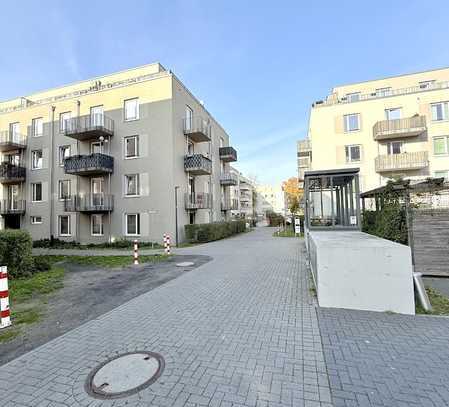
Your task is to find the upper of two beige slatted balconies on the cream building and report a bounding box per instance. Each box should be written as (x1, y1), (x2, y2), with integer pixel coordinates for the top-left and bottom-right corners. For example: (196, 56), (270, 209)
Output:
(373, 116), (427, 140)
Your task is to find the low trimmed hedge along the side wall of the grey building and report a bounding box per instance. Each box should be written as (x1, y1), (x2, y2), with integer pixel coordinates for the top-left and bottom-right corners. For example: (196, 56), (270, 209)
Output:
(184, 220), (246, 243)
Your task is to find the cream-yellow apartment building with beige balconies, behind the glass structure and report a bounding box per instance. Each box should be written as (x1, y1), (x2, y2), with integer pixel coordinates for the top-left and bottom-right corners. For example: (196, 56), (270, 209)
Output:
(297, 68), (449, 191)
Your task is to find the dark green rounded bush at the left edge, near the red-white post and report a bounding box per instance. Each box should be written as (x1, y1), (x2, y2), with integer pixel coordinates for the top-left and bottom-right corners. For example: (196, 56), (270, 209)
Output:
(0, 229), (34, 278)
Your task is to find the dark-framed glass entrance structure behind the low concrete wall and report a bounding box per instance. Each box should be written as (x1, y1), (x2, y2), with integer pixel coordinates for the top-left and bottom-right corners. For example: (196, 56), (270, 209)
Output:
(304, 168), (361, 230)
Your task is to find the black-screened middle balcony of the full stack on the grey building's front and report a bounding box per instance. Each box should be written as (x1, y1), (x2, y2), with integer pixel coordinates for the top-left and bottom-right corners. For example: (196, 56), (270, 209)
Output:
(64, 153), (114, 175)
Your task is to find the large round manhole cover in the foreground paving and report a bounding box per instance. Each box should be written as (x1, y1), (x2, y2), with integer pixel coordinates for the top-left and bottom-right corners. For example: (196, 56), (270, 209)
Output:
(85, 351), (165, 399)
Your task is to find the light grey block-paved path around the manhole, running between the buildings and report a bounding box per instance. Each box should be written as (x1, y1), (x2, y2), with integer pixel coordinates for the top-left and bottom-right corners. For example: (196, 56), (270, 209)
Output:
(0, 228), (332, 407)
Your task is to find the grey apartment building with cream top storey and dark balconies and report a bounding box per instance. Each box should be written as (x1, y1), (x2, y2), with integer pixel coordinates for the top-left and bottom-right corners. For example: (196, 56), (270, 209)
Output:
(0, 63), (237, 243)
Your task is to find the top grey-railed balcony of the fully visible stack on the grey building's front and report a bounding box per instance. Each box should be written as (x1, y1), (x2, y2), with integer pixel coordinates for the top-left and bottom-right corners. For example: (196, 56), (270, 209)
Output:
(61, 114), (114, 141)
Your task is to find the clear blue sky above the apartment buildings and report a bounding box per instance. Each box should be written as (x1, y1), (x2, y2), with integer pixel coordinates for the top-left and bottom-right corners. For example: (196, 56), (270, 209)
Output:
(0, 0), (449, 184)
